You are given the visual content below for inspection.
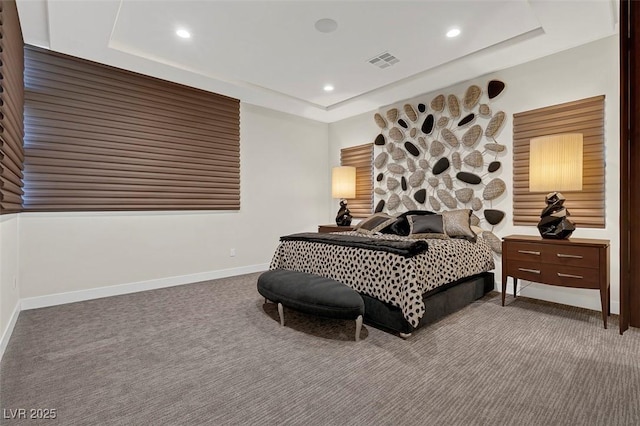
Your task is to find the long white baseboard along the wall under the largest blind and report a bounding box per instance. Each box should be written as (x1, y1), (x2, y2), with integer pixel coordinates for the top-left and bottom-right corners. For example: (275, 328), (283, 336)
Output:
(20, 263), (269, 310)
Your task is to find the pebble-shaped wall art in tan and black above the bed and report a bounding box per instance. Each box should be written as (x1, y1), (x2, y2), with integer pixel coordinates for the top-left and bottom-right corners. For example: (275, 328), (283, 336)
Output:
(374, 80), (507, 253)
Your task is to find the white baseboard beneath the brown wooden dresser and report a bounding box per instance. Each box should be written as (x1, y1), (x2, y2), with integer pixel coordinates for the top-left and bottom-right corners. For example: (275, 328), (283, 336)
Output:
(507, 280), (620, 315)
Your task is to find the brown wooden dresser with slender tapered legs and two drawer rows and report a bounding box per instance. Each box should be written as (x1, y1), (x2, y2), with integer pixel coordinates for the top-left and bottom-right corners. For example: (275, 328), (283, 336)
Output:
(502, 235), (610, 328)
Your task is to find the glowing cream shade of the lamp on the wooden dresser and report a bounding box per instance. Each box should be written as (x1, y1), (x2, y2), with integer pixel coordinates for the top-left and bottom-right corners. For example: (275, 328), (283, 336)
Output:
(529, 133), (582, 192)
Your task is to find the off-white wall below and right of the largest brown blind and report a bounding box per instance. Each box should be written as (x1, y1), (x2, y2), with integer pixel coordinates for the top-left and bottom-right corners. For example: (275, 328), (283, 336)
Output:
(16, 103), (329, 300)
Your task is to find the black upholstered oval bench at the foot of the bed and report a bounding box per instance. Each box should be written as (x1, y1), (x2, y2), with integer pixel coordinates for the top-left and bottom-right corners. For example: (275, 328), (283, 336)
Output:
(258, 269), (364, 342)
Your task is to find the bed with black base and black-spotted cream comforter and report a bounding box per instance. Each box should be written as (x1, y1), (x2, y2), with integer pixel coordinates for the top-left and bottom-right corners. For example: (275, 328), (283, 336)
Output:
(270, 212), (495, 337)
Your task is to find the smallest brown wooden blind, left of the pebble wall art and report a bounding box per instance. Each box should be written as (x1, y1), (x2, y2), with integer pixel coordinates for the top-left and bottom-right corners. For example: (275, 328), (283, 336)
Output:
(340, 143), (373, 217)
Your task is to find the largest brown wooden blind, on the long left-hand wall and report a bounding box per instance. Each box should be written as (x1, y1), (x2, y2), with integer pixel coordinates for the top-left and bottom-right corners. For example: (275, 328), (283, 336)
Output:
(24, 46), (240, 211)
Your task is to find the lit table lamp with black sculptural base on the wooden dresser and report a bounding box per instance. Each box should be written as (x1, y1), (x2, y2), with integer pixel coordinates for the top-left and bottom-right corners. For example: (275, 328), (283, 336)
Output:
(529, 133), (582, 240)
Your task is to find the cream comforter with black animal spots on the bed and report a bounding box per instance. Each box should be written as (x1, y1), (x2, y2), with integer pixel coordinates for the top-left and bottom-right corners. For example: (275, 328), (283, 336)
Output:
(270, 232), (495, 327)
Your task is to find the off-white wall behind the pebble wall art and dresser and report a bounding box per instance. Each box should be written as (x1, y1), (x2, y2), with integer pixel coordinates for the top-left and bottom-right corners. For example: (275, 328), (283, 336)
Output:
(329, 36), (620, 313)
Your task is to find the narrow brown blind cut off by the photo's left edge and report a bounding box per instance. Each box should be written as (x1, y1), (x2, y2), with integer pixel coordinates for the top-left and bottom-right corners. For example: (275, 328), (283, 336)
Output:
(0, 0), (24, 214)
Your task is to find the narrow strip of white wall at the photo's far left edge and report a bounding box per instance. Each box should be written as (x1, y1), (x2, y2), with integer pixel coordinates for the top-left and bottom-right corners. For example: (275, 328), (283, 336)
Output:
(0, 214), (20, 358)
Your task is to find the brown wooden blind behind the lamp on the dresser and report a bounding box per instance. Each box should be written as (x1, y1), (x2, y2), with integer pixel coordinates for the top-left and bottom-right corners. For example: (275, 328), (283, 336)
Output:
(513, 96), (605, 228)
